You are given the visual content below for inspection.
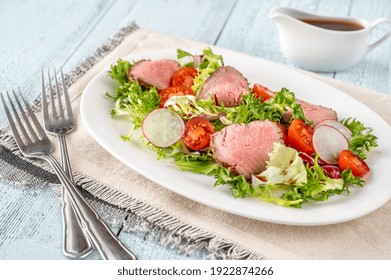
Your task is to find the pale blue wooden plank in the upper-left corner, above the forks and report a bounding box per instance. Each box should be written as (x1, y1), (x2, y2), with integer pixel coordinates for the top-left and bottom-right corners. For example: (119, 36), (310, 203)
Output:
(0, 0), (116, 116)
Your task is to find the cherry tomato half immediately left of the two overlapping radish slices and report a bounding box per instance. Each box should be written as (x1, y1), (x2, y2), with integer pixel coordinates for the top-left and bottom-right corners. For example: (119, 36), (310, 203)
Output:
(288, 119), (315, 155)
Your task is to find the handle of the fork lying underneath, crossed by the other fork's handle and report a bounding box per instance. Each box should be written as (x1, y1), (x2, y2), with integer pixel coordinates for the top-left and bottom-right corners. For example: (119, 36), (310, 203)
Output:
(58, 134), (94, 259)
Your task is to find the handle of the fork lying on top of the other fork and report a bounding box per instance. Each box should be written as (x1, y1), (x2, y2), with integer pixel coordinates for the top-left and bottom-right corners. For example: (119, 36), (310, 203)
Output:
(42, 155), (136, 260)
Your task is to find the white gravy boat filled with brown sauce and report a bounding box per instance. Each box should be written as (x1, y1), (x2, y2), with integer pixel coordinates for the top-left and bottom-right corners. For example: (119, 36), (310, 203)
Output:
(269, 7), (391, 72)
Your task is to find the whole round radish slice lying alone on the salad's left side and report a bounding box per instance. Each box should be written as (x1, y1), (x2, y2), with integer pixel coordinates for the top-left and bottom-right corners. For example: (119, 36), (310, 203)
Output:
(142, 108), (185, 148)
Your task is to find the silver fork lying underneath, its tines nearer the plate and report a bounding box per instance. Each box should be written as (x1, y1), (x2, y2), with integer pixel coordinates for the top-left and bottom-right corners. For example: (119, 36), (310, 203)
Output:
(42, 69), (93, 259)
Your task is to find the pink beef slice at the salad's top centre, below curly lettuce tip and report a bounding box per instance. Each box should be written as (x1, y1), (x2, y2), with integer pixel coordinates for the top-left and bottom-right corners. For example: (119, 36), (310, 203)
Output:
(199, 66), (248, 107)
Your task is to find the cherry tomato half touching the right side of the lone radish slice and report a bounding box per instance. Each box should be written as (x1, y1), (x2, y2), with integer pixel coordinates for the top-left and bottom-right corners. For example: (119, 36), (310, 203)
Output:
(182, 117), (214, 151)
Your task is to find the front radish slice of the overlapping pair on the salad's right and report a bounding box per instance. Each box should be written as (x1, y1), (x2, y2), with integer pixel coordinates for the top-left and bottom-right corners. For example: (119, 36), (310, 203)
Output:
(312, 125), (349, 164)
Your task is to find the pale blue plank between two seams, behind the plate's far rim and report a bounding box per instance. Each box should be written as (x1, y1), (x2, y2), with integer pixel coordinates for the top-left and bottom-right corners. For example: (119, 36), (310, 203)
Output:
(57, 0), (235, 70)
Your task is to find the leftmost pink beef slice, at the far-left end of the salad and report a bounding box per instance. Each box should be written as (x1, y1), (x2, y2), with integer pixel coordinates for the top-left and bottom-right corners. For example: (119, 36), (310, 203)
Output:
(128, 59), (180, 90)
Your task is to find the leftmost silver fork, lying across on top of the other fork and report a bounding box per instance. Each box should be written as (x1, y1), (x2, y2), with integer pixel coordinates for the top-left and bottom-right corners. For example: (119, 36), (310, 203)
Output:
(0, 91), (136, 260)
